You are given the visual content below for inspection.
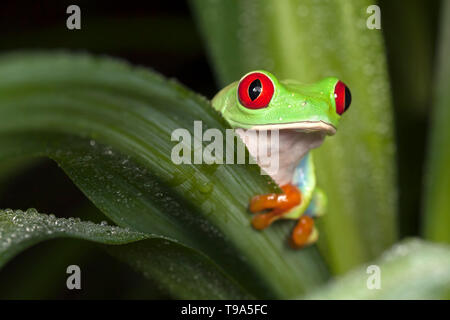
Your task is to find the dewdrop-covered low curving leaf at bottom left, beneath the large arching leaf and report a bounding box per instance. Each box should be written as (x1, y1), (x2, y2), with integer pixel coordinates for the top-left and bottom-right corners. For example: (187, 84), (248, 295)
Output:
(0, 209), (250, 299)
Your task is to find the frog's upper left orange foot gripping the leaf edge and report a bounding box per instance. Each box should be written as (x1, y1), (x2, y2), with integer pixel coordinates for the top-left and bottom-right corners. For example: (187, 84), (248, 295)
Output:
(250, 184), (302, 230)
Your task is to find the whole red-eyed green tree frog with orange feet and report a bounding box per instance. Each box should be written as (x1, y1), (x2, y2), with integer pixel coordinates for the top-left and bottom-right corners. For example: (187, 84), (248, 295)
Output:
(212, 70), (351, 248)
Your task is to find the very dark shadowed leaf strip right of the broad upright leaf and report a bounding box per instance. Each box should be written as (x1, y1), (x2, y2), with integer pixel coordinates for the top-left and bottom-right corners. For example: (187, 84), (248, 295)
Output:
(378, 0), (440, 238)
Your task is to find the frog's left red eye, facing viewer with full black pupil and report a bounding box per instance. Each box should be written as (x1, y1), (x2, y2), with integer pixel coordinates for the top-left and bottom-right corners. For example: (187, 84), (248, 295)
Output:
(238, 72), (274, 109)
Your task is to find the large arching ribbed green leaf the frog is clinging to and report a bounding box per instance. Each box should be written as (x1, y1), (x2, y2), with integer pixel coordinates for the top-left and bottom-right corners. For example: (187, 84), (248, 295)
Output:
(0, 54), (328, 298)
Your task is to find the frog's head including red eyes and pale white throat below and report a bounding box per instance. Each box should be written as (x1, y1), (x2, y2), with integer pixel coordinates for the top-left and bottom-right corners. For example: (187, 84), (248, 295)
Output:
(212, 71), (351, 185)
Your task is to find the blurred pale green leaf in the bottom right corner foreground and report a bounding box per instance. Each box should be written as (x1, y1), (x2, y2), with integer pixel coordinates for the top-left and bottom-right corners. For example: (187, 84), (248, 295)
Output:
(306, 239), (450, 299)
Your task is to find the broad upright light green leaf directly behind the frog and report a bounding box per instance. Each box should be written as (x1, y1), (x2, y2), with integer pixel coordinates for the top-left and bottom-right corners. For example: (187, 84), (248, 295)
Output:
(192, 0), (397, 272)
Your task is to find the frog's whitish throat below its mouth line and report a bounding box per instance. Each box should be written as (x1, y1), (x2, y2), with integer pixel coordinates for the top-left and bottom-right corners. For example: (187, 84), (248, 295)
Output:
(236, 129), (326, 186)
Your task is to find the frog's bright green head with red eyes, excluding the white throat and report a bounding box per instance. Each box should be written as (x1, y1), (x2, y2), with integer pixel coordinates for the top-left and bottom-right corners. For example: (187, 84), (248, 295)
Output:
(213, 71), (351, 135)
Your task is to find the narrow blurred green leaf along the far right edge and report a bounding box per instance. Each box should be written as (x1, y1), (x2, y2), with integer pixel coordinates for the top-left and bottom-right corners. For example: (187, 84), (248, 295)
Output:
(423, 1), (450, 242)
